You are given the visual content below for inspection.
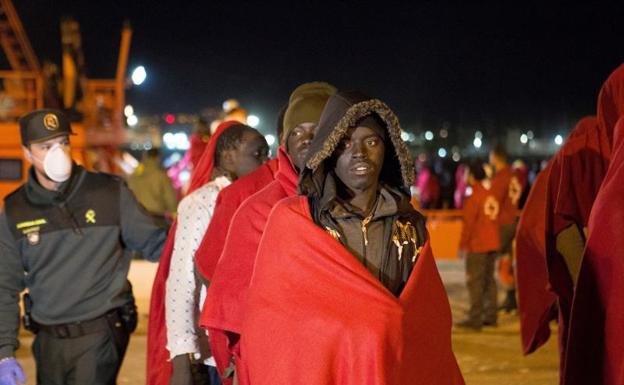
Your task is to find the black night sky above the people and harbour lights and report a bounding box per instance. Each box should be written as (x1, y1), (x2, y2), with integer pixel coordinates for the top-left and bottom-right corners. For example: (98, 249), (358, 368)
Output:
(15, 0), (624, 136)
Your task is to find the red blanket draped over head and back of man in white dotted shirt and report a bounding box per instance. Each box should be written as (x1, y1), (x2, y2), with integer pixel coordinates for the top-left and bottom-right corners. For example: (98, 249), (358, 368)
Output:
(146, 120), (238, 385)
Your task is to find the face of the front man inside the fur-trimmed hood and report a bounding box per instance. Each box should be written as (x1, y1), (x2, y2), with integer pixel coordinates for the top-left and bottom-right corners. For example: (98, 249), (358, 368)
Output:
(335, 126), (385, 195)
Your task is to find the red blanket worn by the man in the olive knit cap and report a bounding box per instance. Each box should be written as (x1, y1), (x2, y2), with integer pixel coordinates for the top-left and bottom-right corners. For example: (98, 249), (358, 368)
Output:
(200, 147), (298, 385)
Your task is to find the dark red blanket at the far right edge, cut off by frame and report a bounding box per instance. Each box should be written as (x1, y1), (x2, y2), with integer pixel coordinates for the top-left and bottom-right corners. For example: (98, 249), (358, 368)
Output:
(564, 119), (624, 385)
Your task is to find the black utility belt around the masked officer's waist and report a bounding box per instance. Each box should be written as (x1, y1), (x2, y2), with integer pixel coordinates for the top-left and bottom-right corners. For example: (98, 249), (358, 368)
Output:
(23, 294), (138, 338)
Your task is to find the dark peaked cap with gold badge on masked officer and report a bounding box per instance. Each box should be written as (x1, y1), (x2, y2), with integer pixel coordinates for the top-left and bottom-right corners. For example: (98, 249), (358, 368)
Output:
(19, 109), (74, 146)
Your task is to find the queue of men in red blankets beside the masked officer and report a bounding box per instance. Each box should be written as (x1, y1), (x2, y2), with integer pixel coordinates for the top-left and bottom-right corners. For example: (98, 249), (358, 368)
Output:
(148, 82), (463, 385)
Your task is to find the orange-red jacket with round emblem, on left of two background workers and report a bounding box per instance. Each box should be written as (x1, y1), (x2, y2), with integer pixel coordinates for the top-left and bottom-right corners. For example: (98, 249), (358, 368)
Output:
(459, 183), (500, 253)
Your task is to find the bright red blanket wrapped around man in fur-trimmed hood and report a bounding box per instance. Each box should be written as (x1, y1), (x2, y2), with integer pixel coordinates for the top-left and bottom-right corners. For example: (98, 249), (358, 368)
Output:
(241, 197), (464, 385)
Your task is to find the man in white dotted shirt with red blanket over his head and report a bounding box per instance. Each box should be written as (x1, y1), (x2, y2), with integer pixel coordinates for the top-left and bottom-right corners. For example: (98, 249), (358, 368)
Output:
(148, 121), (268, 384)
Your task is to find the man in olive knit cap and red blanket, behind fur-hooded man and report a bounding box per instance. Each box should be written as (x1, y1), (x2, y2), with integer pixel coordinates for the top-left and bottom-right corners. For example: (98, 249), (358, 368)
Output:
(200, 82), (336, 384)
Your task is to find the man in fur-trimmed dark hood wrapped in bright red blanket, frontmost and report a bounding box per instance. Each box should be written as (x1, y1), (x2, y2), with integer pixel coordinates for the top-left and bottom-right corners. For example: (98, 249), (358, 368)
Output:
(241, 92), (463, 385)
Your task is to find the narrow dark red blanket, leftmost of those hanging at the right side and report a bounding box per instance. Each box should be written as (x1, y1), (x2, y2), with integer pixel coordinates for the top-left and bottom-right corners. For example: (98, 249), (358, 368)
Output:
(516, 163), (556, 354)
